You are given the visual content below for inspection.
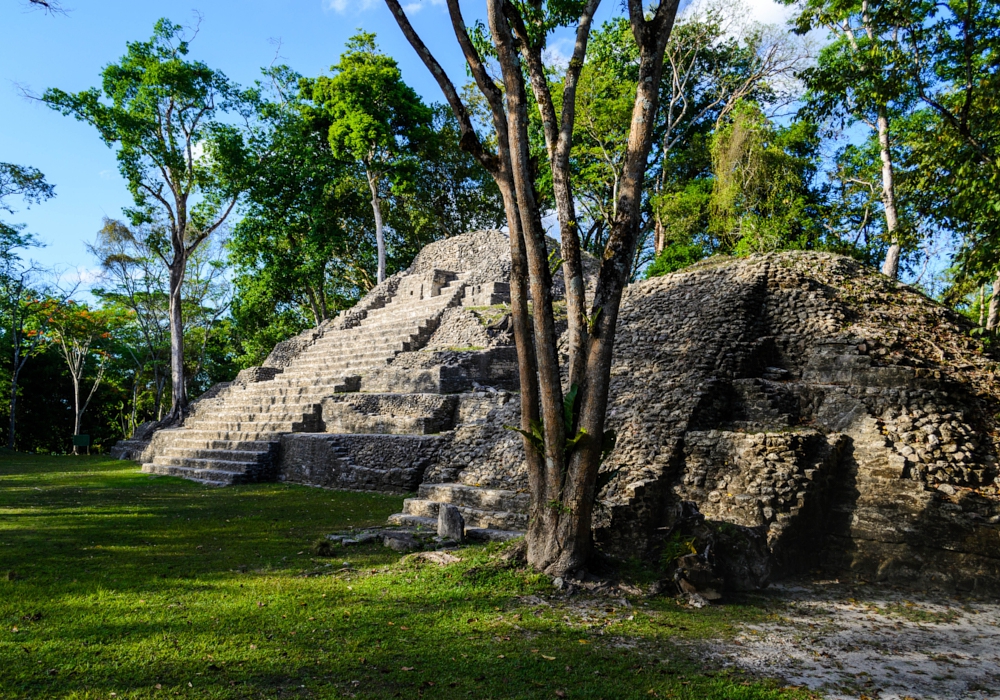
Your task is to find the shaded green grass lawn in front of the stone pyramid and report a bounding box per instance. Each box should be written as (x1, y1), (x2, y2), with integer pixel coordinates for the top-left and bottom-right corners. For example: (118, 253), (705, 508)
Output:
(0, 453), (808, 700)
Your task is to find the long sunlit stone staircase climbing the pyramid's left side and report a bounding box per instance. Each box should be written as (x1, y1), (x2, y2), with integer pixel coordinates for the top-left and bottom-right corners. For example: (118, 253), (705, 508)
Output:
(142, 270), (465, 486)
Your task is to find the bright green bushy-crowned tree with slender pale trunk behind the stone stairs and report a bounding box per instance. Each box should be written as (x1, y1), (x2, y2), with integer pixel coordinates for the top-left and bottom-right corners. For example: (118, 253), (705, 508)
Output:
(303, 32), (432, 283)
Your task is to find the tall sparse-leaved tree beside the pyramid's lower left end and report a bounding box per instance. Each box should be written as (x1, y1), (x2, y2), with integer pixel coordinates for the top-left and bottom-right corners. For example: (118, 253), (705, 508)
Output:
(41, 19), (252, 421)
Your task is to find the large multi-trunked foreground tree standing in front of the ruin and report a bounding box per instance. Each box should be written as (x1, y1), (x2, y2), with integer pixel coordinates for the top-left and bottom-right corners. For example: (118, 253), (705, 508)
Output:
(386, 0), (678, 574)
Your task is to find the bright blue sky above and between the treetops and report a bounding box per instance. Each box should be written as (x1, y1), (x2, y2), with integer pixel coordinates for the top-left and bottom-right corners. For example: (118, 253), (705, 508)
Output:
(0, 0), (796, 282)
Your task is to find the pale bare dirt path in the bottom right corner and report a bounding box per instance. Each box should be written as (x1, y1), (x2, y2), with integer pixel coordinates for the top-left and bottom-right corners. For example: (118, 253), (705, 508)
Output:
(715, 582), (1000, 700)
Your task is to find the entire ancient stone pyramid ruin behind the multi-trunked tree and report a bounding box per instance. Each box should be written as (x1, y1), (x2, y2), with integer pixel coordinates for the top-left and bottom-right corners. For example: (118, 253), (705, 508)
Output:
(119, 231), (1000, 590)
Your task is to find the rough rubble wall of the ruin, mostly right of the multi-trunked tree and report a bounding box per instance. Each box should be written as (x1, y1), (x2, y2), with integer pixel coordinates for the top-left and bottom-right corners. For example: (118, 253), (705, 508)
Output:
(406, 253), (1000, 590)
